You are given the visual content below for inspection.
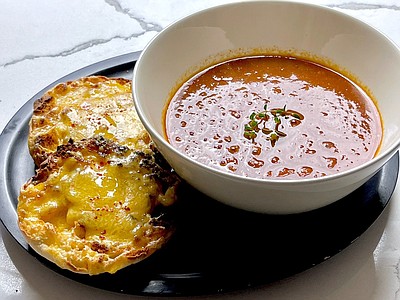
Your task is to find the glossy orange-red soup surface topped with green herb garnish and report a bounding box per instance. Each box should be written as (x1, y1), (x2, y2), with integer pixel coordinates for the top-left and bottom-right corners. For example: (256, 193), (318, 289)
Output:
(165, 56), (382, 179)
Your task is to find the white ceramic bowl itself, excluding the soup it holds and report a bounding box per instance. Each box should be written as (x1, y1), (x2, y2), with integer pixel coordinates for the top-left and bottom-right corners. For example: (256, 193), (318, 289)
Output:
(133, 1), (400, 214)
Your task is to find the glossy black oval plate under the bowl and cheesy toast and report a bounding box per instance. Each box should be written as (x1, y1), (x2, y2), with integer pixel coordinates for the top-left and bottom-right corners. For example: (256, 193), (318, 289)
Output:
(0, 53), (399, 296)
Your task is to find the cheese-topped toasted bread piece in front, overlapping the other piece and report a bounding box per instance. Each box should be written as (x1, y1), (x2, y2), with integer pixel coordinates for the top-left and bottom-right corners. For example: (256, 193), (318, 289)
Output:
(17, 137), (179, 275)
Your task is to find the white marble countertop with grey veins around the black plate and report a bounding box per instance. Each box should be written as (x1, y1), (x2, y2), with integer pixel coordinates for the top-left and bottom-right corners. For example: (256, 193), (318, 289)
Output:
(0, 0), (400, 300)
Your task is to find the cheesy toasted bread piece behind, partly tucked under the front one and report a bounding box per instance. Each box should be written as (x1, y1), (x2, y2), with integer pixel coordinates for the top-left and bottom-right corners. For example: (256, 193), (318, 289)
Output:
(28, 76), (150, 166)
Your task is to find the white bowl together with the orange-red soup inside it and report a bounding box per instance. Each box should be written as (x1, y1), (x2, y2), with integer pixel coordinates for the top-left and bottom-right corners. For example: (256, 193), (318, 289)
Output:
(133, 1), (400, 214)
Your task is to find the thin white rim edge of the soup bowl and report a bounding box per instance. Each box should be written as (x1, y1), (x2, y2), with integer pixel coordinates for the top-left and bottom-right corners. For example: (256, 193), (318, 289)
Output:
(132, 0), (400, 186)
